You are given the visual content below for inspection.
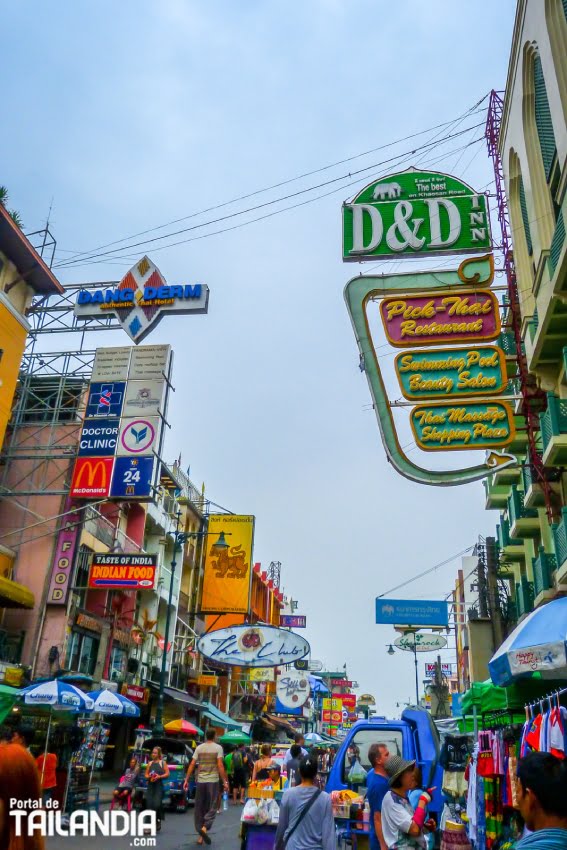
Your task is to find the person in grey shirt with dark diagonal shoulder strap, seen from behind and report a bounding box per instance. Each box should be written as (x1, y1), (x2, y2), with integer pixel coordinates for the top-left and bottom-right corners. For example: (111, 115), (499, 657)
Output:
(274, 756), (336, 850)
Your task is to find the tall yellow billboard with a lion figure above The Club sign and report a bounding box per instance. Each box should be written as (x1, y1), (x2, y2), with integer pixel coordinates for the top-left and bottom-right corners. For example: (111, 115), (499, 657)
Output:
(201, 514), (254, 614)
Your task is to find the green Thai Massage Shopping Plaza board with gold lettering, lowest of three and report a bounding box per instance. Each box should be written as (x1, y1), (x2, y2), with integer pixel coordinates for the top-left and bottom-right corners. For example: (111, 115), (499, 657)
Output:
(410, 401), (514, 452)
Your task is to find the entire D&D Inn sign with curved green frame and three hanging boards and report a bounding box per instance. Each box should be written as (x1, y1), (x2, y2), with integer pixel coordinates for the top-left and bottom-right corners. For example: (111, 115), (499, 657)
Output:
(343, 169), (517, 485)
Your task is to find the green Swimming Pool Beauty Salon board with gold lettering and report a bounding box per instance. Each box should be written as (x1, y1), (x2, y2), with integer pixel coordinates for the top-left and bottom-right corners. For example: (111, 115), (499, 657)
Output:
(395, 345), (507, 401)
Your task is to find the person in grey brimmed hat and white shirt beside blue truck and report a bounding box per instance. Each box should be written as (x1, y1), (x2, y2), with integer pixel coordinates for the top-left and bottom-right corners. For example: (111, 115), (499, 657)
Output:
(382, 756), (434, 850)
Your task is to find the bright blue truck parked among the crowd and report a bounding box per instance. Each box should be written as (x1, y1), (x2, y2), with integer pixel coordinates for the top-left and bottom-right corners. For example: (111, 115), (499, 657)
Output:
(326, 708), (443, 822)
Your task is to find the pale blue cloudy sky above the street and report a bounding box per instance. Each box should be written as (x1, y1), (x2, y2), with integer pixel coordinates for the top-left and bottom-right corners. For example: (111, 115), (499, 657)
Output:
(0, 0), (515, 716)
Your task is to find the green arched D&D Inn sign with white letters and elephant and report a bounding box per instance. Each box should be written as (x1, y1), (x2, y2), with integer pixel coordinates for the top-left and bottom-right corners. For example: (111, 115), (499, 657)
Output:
(343, 169), (491, 262)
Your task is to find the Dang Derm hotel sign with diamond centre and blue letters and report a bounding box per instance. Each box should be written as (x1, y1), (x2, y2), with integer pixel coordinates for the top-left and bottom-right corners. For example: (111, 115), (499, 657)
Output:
(75, 257), (209, 343)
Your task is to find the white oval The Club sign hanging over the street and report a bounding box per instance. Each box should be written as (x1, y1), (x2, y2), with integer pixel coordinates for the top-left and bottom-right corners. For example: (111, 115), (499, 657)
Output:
(197, 624), (311, 667)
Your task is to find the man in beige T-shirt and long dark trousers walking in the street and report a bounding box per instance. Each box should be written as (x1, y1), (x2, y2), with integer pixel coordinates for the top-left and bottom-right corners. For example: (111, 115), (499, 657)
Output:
(183, 729), (228, 844)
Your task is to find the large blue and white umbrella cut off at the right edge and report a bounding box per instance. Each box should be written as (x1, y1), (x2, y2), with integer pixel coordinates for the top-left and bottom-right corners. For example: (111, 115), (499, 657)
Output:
(488, 597), (567, 687)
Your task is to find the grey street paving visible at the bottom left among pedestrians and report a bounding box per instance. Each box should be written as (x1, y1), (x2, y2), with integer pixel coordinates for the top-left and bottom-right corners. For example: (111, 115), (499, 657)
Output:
(47, 806), (242, 850)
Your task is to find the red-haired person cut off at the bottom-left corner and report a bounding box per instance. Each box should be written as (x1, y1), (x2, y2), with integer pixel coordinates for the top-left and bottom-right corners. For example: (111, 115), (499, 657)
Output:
(0, 744), (45, 850)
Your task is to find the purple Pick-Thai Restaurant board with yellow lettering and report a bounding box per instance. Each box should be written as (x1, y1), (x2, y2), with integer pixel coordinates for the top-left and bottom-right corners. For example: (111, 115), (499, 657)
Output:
(380, 289), (500, 348)
